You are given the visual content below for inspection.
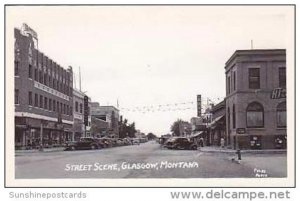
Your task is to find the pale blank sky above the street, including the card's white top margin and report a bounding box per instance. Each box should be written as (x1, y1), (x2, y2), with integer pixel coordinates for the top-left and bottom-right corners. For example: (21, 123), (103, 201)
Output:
(6, 6), (292, 135)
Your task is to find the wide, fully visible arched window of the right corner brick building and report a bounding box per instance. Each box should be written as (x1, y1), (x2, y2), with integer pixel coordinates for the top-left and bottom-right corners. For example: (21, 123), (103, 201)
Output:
(246, 102), (264, 128)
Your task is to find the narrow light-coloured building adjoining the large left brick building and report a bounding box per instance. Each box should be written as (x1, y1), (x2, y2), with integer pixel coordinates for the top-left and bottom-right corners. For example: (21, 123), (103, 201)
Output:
(72, 89), (92, 140)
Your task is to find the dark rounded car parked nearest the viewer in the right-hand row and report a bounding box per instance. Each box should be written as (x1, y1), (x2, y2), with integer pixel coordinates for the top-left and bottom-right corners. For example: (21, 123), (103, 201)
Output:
(164, 137), (198, 150)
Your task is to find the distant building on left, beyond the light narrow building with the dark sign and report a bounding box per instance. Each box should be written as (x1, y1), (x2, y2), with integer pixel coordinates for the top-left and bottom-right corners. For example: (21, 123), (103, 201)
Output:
(91, 102), (119, 137)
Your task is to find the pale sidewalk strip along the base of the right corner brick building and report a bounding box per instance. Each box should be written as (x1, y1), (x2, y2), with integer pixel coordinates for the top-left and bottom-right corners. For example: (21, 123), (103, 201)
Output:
(198, 146), (286, 154)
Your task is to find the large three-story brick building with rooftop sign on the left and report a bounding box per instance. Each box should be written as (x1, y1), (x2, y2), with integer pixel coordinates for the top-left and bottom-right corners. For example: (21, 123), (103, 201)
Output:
(14, 24), (73, 148)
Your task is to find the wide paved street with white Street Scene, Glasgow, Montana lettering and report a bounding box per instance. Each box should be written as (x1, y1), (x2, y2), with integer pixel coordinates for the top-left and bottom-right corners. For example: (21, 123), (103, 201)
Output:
(15, 142), (287, 179)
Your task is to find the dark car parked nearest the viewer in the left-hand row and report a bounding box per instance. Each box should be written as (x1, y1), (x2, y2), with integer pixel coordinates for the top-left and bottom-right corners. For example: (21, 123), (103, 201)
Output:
(65, 137), (101, 151)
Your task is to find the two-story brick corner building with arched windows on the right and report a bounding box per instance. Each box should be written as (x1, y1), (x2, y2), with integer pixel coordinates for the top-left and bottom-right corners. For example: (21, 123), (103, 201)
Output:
(225, 49), (287, 149)
